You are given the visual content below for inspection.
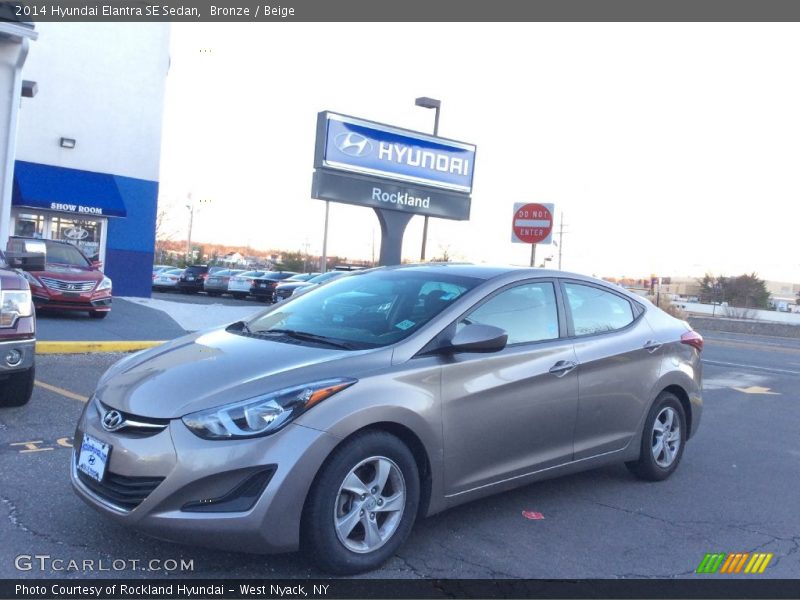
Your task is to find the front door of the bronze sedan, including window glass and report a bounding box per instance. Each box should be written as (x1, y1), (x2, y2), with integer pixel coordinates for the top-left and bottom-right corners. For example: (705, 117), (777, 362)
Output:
(442, 279), (578, 495)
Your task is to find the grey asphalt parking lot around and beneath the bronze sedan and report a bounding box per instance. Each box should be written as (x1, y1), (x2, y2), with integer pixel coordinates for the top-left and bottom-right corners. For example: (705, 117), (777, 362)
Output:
(0, 330), (800, 578)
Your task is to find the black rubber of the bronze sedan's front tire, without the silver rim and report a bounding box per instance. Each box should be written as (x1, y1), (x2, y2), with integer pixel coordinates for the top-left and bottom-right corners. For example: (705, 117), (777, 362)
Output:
(301, 431), (420, 575)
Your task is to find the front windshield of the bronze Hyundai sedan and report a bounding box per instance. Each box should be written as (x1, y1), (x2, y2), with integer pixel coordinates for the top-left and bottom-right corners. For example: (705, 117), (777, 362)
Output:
(242, 269), (482, 349)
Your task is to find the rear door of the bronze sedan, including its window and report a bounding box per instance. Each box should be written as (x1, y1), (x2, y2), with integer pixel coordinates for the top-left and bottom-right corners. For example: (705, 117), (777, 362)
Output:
(562, 280), (664, 460)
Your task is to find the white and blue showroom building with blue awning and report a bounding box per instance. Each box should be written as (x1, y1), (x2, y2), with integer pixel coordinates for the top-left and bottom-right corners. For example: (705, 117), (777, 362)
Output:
(9, 23), (169, 296)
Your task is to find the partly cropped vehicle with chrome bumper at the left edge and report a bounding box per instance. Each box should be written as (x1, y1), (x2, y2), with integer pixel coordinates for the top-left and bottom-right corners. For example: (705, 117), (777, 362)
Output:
(0, 240), (45, 407)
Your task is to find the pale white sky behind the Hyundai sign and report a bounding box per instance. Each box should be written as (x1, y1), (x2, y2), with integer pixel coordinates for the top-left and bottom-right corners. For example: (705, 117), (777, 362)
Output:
(159, 23), (800, 282)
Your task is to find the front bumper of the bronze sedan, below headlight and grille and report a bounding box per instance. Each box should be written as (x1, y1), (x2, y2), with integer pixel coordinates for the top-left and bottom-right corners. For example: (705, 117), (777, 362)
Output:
(71, 402), (339, 553)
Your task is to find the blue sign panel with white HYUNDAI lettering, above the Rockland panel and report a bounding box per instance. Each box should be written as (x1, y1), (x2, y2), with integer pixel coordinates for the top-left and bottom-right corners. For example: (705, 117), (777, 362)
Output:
(317, 112), (475, 193)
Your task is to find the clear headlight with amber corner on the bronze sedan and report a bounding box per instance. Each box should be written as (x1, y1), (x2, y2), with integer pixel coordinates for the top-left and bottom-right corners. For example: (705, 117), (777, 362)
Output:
(182, 377), (356, 440)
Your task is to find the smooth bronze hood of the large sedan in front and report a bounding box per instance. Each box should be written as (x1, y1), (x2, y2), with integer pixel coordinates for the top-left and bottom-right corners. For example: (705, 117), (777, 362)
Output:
(96, 329), (391, 419)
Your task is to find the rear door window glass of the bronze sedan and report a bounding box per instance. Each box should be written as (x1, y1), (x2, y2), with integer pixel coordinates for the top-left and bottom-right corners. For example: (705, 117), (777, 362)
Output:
(564, 283), (634, 335)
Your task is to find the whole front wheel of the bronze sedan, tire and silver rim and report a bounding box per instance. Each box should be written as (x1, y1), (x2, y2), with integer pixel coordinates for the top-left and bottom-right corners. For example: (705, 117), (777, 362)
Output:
(301, 431), (420, 575)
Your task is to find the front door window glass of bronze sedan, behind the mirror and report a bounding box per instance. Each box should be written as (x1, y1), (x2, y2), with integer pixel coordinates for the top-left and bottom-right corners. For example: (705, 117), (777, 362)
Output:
(458, 282), (558, 344)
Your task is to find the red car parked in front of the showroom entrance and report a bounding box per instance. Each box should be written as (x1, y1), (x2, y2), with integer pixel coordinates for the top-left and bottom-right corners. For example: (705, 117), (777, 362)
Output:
(8, 237), (111, 319)
